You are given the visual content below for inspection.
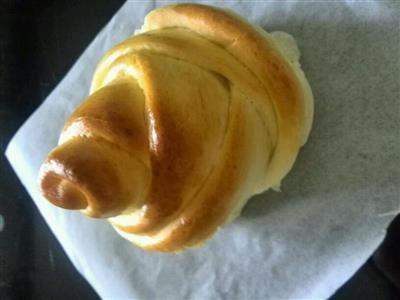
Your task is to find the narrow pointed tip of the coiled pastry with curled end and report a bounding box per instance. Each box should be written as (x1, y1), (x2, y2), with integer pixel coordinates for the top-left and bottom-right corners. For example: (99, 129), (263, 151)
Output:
(40, 82), (150, 217)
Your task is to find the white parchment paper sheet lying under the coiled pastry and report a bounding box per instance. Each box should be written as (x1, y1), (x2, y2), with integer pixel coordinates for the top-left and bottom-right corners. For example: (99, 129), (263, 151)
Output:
(6, 1), (400, 299)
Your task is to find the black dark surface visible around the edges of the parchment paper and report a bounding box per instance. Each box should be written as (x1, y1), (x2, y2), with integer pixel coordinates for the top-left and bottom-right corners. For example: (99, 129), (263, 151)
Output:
(0, 0), (400, 300)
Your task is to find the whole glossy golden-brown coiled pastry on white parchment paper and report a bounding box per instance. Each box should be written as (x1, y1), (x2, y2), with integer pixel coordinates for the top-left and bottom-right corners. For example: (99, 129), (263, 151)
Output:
(39, 4), (313, 252)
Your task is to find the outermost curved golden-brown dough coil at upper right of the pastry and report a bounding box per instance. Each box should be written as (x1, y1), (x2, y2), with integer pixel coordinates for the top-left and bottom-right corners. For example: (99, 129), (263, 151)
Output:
(143, 4), (309, 189)
